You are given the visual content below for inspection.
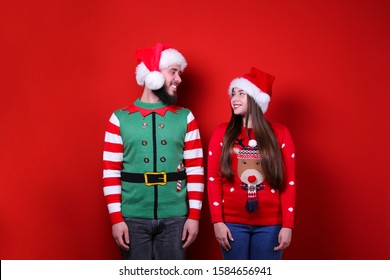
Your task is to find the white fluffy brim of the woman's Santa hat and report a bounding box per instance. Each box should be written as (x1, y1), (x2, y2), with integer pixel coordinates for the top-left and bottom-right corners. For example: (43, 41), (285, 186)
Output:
(229, 78), (271, 114)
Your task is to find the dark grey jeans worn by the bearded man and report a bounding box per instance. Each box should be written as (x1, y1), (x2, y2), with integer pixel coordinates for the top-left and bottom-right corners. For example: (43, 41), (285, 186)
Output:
(122, 216), (187, 260)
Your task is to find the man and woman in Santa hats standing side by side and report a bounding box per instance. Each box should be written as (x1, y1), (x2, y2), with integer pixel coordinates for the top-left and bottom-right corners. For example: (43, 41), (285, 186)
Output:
(103, 44), (295, 260)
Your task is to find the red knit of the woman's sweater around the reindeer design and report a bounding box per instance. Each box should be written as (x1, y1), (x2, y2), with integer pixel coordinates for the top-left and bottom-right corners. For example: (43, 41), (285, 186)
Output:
(207, 123), (296, 228)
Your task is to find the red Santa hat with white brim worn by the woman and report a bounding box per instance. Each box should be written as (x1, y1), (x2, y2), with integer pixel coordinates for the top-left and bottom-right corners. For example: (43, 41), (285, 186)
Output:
(229, 67), (275, 114)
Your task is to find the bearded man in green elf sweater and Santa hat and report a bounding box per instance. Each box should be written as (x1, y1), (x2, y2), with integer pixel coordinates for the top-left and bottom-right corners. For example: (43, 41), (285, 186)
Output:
(103, 44), (204, 259)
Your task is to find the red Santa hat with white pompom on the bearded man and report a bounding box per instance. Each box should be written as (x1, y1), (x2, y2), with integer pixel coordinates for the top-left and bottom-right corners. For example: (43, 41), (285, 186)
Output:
(135, 43), (187, 90)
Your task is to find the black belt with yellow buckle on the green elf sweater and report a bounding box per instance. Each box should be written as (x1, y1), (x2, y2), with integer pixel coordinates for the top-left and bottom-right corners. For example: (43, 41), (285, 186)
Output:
(121, 170), (187, 186)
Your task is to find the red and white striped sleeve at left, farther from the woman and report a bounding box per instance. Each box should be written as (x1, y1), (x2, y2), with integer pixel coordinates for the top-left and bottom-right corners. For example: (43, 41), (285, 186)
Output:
(103, 113), (123, 224)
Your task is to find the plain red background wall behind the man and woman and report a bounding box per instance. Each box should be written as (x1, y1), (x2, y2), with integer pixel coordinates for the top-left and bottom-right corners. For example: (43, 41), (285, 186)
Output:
(0, 0), (390, 259)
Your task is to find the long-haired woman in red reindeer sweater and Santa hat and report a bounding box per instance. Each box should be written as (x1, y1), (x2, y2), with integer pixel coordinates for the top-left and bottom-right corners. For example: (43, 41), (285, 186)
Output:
(207, 67), (295, 260)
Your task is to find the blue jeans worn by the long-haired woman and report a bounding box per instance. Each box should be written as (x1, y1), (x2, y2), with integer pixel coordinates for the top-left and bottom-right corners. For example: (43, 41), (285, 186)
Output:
(221, 223), (283, 260)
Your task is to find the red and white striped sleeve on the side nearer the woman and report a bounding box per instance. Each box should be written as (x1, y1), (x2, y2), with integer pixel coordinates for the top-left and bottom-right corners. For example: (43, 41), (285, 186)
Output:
(184, 112), (204, 220)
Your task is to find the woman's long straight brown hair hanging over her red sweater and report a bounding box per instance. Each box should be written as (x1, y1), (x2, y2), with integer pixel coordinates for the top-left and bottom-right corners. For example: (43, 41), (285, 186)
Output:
(219, 95), (283, 188)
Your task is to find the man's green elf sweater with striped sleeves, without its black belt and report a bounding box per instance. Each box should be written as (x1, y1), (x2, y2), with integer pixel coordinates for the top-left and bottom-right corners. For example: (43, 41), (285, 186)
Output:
(103, 99), (204, 224)
